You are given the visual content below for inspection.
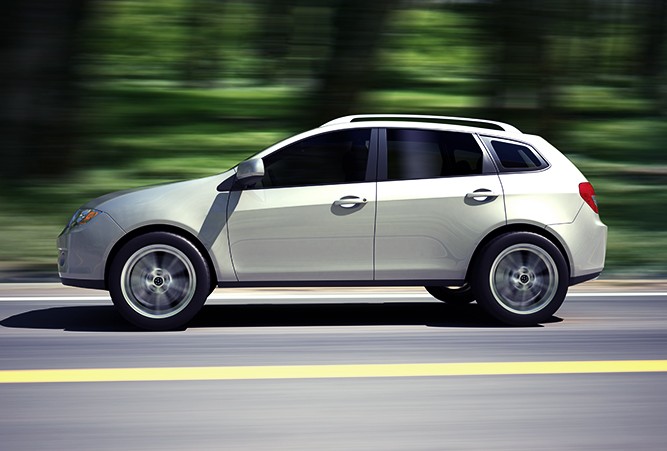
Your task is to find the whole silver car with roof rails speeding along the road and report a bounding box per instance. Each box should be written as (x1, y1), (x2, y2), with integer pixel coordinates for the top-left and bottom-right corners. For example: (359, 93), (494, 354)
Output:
(58, 115), (607, 330)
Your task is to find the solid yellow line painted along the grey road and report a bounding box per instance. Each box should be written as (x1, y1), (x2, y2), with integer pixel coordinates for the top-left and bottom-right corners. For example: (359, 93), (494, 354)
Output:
(0, 360), (667, 384)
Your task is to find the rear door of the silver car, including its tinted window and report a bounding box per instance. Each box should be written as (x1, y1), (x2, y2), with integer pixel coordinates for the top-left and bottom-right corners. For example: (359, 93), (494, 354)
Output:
(375, 128), (505, 281)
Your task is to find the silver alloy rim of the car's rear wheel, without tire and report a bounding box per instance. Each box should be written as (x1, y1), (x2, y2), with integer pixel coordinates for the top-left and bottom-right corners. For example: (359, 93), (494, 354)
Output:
(489, 243), (558, 315)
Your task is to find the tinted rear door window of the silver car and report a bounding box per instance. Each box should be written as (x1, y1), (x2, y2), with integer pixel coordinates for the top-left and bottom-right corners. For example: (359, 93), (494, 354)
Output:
(387, 128), (482, 180)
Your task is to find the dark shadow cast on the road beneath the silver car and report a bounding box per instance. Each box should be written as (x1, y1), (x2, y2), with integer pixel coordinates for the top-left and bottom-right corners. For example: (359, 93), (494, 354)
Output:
(0, 302), (562, 332)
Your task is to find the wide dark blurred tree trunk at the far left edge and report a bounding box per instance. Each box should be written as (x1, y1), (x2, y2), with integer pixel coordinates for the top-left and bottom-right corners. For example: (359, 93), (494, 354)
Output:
(0, 0), (88, 184)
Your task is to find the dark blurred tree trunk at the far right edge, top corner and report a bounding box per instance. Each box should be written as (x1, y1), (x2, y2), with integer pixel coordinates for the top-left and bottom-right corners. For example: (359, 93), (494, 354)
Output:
(639, 0), (667, 114)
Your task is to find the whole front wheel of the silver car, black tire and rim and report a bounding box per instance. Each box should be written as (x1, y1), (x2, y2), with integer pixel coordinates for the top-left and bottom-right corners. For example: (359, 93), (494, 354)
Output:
(108, 232), (211, 330)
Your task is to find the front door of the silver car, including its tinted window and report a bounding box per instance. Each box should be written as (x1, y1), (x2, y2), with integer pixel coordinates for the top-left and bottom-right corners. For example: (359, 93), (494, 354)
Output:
(228, 128), (377, 282)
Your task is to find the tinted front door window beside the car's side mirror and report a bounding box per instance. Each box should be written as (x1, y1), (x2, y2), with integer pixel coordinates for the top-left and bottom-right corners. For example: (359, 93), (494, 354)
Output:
(256, 129), (371, 188)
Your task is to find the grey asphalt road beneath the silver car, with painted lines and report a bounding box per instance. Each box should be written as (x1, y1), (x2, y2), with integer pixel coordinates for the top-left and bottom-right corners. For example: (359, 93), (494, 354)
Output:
(0, 285), (667, 451)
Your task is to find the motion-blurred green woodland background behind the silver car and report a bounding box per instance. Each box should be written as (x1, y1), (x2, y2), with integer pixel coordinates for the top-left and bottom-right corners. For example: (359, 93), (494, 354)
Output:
(0, 0), (667, 280)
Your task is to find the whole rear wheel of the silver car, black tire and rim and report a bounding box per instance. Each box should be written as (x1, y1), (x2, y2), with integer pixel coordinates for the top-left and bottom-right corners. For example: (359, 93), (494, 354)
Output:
(471, 232), (569, 326)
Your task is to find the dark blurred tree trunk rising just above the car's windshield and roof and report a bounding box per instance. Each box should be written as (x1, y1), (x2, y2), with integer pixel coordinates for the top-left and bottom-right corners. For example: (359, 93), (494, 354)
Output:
(305, 0), (398, 125)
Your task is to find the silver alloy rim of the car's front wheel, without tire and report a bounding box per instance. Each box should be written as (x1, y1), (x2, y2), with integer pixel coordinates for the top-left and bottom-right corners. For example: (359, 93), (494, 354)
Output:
(121, 244), (196, 319)
